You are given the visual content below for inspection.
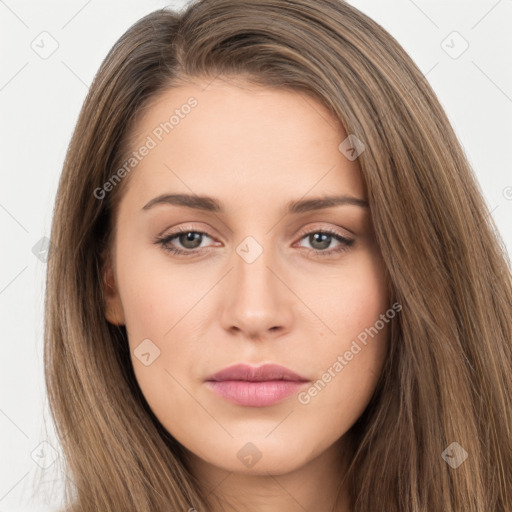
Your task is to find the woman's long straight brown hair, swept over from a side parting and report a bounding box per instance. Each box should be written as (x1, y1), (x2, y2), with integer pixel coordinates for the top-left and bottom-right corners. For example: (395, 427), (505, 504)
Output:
(45, 0), (512, 512)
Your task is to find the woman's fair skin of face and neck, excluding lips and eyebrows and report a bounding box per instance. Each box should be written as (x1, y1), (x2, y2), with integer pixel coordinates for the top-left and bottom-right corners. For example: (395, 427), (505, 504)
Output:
(105, 78), (390, 512)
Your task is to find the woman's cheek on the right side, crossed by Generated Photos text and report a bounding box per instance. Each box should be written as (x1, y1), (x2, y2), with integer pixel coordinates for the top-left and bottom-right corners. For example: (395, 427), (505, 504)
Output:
(298, 252), (390, 416)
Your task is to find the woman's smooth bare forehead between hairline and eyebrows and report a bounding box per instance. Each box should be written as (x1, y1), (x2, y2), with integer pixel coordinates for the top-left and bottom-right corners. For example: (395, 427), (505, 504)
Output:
(122, 79), (365, 212)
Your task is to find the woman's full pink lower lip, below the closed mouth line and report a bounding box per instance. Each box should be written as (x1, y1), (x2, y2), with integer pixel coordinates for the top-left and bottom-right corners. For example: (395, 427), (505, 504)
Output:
(207, 380), (306, 407)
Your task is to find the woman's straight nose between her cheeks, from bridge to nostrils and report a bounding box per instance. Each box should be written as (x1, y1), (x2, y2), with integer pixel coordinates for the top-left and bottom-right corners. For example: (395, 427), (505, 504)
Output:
(221, 239), (297, 339)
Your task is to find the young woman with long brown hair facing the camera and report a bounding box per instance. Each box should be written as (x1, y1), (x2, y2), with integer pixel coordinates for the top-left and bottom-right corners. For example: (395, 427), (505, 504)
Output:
(45, 0), (512, 512)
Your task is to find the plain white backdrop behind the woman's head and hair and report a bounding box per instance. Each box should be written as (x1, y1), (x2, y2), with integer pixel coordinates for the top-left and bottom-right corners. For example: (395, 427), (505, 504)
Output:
(0, 0), (512, 512)
